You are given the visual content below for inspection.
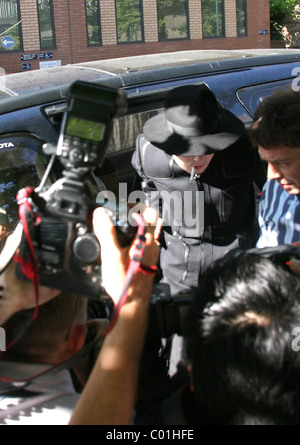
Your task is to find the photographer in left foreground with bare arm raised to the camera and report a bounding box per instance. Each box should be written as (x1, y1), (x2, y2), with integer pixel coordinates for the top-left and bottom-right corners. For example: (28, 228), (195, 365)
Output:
(0, 205), (159, 425)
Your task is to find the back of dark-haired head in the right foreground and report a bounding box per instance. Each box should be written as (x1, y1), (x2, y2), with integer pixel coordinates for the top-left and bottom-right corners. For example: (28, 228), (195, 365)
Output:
(185, 254), (300, 424)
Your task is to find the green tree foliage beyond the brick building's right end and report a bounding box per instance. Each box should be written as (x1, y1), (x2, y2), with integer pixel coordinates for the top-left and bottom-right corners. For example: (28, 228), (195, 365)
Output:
(270, 0), (299, 41)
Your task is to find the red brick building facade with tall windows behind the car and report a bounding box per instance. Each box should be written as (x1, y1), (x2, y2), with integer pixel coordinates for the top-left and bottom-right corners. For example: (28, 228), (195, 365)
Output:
(0, 0), (270, 73)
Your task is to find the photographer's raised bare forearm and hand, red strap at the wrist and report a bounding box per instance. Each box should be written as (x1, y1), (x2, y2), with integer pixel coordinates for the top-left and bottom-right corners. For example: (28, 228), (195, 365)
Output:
(70, 208), (160, 425)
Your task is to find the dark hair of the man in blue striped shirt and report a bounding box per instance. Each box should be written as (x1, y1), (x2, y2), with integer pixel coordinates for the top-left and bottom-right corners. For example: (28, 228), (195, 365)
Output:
(249, 90), (300, 149)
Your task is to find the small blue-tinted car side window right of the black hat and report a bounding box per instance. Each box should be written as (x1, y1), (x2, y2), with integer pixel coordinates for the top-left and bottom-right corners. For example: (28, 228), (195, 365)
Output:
(237, 79), (293, 116)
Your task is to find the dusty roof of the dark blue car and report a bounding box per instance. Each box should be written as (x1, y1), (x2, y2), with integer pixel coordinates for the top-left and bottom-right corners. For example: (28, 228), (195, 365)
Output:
(0, 48), (300, 113)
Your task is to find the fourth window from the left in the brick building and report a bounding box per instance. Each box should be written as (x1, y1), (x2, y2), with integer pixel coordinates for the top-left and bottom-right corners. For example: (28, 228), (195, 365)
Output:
(116, 0), (144, 43)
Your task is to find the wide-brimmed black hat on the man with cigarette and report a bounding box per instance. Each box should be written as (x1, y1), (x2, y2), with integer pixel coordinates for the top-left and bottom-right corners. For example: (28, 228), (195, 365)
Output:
(143, 84), (245, 156)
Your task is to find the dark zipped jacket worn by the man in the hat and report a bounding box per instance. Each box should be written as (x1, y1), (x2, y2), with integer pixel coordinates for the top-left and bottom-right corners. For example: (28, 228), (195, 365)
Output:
(132, 135), (266, 293)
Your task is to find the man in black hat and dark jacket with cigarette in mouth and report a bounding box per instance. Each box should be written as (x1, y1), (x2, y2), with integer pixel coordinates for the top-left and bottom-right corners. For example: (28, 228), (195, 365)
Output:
(132, 84), (266, 295)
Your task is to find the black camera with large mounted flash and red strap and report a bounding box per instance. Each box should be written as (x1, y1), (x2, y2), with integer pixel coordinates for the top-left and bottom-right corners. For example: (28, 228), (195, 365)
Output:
(17, 81), (136, 298)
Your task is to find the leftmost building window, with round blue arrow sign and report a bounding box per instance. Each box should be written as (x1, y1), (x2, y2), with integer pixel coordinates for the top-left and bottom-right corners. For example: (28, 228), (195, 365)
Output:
(0, 0), (22, 52)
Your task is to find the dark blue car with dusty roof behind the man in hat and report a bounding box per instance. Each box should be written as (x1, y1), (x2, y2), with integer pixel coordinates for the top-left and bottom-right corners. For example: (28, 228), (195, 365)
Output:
(0, 49), (300, 278)
